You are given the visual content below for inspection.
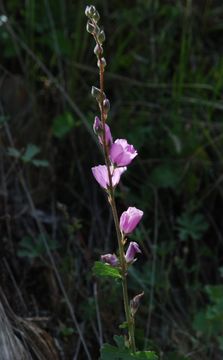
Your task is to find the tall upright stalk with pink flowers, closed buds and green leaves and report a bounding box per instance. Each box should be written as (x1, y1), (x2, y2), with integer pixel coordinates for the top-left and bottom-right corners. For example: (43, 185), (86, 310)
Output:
(85, 5), (156, 360)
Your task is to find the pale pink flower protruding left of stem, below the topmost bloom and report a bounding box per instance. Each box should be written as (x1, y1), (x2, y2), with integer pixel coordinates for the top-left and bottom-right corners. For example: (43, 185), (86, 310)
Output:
(91, 165), (126, 189)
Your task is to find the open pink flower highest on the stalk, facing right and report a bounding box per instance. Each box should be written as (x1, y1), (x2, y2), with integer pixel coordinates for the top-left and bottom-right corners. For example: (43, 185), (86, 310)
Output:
(110, 139), (138, 166)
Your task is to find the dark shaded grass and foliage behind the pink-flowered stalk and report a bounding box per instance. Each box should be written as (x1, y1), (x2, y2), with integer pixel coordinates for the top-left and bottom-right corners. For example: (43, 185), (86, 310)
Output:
(0, 0), (223, 360)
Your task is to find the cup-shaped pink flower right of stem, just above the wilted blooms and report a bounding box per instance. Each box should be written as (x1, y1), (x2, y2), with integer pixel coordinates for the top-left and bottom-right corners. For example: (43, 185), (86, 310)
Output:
(119, 207), (143, 234)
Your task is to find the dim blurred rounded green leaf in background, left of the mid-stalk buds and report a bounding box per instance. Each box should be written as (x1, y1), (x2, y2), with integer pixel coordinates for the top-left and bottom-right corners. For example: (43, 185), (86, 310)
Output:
(52, 112), (75, 139)
